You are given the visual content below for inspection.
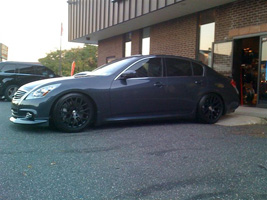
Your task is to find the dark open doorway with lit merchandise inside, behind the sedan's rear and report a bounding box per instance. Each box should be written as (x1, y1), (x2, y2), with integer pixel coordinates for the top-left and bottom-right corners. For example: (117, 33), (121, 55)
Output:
(233, 37), (260, 106)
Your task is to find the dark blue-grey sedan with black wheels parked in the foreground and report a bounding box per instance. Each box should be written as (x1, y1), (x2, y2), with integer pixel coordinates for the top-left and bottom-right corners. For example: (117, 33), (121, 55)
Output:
(10, 55), (239, 132)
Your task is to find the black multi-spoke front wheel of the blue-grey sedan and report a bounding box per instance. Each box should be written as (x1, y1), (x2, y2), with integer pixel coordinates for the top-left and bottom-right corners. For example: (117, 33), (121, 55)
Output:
(52, 93), (94, 132)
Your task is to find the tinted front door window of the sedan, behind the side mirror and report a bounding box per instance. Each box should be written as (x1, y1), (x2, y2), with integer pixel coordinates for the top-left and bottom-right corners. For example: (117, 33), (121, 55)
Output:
(130, 58), (162, 77)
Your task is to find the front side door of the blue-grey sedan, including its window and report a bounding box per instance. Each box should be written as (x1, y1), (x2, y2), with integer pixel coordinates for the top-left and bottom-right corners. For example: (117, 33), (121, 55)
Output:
(110, 58), (170, 117)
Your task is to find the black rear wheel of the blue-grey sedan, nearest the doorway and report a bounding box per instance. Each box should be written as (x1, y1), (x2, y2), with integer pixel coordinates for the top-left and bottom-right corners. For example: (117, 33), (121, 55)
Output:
(197, 94), (224, 124)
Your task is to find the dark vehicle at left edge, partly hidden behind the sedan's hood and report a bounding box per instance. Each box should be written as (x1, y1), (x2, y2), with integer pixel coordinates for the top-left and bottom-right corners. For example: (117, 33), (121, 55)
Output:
(0, 61), (56, 101)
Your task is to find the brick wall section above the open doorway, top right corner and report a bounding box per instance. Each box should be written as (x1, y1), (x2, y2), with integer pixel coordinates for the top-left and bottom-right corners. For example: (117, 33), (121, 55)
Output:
(215, 0), (267, 41)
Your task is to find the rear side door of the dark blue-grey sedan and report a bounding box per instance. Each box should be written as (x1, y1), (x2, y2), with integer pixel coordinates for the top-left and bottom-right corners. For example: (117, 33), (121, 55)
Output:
(165, 58), (206, 114)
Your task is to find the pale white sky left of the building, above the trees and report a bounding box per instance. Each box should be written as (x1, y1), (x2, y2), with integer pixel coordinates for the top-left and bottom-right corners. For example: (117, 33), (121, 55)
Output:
(0, 0), (83, 62)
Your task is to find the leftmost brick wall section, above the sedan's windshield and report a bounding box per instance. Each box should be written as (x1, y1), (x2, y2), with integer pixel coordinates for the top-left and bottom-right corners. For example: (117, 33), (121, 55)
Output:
(98, 35), (124, 66)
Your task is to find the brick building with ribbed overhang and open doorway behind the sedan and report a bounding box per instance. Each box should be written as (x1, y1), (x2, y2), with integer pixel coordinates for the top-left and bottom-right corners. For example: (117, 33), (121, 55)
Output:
(68, 0), (267, 107)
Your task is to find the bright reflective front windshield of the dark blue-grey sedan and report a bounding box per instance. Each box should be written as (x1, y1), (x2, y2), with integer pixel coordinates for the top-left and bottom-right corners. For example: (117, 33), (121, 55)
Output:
(75, 57), (136, 76)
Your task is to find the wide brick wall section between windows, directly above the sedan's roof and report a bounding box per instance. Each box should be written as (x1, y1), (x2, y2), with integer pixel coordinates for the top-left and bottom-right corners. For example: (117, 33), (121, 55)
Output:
(150, 14), (197, 58)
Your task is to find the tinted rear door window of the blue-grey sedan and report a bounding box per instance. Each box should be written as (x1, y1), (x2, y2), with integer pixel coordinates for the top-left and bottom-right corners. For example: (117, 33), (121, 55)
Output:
(166, 58), (192, 76)
